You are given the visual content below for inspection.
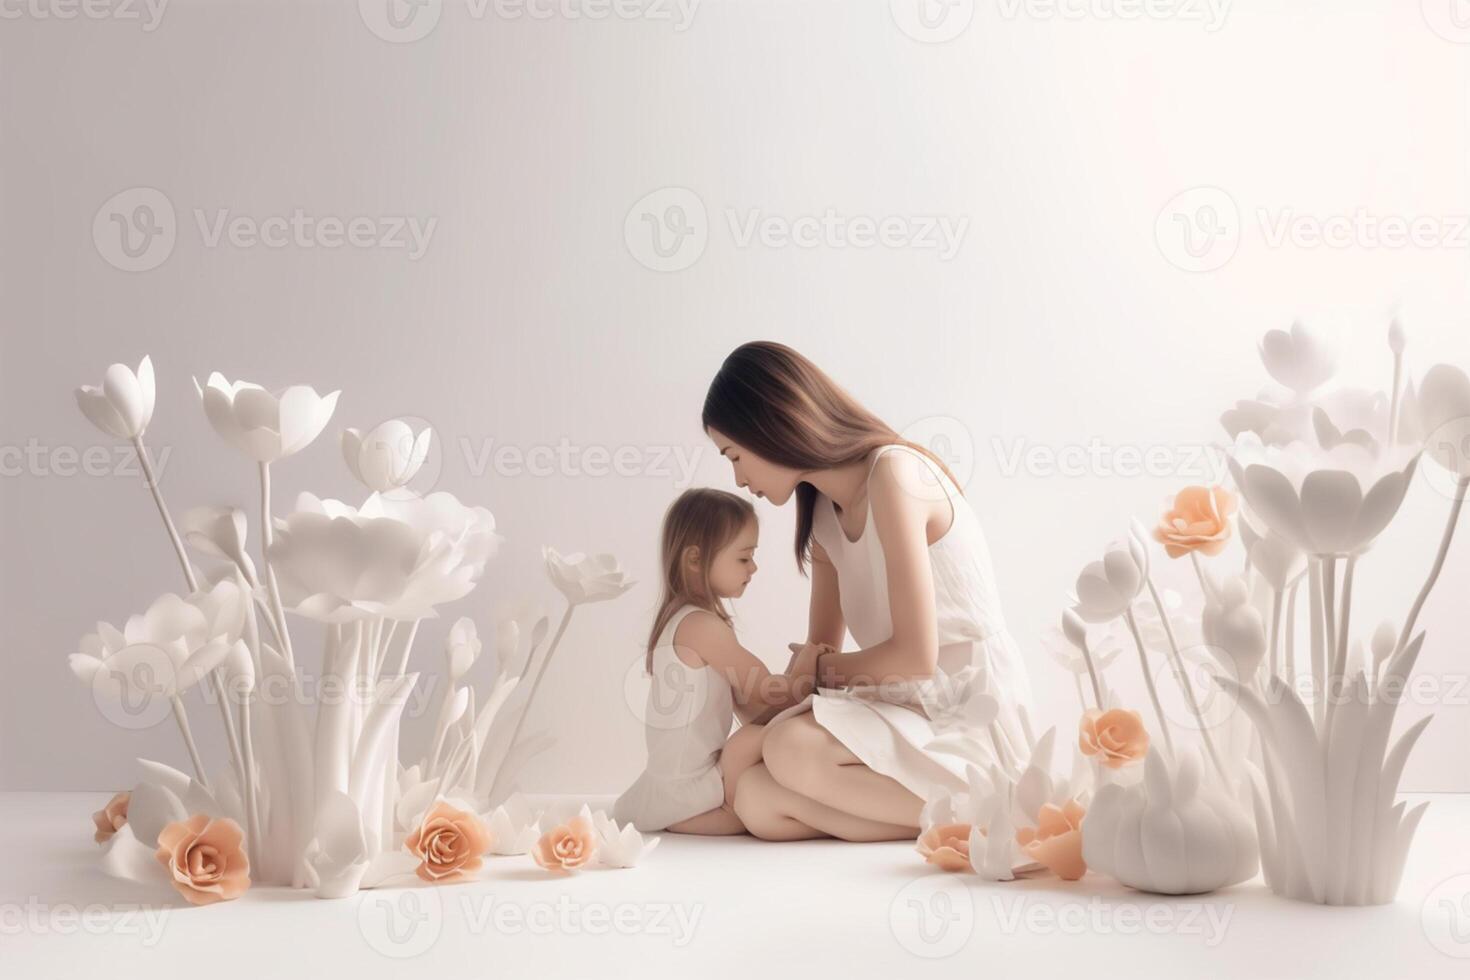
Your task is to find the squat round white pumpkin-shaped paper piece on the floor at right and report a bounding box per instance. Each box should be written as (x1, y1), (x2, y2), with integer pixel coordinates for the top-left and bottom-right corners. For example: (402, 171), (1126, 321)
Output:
(1082, 749), (1258, 895)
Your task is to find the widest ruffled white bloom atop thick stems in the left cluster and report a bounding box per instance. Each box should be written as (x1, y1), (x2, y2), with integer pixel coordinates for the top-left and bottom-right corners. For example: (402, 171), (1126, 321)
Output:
(270, 492), (500, 623)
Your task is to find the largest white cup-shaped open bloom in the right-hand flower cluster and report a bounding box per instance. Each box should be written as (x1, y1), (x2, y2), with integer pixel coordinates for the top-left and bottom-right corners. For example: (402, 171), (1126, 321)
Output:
(1229, 433), (1419, 555)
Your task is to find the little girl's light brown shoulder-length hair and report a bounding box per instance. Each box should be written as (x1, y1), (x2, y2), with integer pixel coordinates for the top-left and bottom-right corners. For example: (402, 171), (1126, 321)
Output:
(644, 486), (756, 673)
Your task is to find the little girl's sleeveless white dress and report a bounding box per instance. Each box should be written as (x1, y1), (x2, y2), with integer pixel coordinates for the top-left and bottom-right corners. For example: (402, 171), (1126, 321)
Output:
(613, 605), (735, 832)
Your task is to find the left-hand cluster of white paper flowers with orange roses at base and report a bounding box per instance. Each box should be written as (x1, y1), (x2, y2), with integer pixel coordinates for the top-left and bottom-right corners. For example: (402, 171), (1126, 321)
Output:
(71, 357), (642, 904)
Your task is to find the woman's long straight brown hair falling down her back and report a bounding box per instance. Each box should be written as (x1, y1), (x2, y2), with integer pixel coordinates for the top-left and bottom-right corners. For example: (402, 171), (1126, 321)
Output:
(704, 341), (958, 573)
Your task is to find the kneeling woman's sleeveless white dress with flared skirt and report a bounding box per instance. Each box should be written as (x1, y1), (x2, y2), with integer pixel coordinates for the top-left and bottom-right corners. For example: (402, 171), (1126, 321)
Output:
(772, 445), (1030, 799)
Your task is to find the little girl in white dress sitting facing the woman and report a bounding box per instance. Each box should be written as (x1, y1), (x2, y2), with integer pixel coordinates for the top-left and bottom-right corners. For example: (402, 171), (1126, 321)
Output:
(613, 488), (823, 835)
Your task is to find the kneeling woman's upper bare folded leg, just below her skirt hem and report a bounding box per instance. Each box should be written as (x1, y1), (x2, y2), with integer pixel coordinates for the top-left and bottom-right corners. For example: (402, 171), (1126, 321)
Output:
(763, 713), (923, 837)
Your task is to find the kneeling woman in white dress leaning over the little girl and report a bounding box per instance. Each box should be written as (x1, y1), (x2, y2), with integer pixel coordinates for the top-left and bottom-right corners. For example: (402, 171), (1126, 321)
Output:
(704, 341), (1030, 840)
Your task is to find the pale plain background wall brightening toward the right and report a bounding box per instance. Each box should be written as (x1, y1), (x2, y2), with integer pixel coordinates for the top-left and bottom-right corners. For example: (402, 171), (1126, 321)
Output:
(0, 0), (1470, 792)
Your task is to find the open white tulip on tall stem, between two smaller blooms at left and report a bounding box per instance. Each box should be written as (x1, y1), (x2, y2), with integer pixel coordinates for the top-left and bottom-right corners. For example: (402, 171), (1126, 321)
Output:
(194, 372), (343, 463)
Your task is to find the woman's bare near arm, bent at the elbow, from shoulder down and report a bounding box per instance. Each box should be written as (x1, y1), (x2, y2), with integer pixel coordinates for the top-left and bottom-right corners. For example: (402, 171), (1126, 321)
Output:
(813, 453), (951, 688)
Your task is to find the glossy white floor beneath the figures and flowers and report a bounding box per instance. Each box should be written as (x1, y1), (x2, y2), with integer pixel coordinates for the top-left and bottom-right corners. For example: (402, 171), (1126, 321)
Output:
(0, 793), (1470, 980)
